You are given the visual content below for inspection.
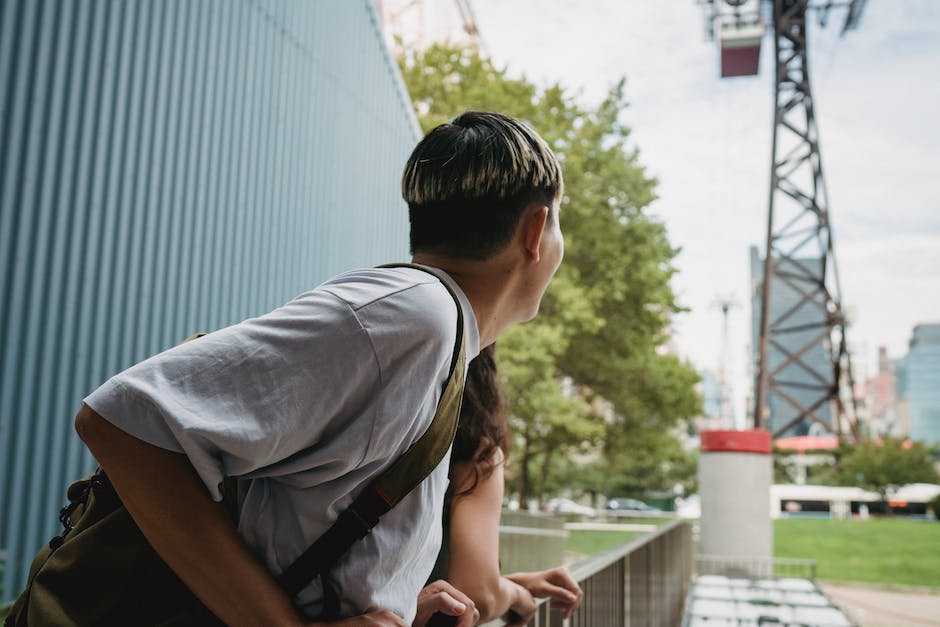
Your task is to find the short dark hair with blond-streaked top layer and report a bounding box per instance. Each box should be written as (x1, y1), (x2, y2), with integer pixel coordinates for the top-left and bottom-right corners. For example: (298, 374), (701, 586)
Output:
(402, 111), (563, 259)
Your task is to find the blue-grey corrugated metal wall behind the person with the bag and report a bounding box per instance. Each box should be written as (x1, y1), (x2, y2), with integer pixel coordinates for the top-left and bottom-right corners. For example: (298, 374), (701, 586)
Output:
(0, 0), (418, 599)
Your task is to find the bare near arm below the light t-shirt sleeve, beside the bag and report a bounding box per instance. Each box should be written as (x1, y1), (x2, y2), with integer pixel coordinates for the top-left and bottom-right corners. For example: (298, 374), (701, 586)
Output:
(75, 405), (304, 626)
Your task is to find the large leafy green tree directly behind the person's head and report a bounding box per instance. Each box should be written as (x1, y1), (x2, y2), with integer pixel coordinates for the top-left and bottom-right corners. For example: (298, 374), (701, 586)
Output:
(400, 45), (701, 501)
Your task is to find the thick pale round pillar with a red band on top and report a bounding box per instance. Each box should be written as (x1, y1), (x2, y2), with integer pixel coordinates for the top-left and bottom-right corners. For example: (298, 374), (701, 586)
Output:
(698, 429), (774, 575)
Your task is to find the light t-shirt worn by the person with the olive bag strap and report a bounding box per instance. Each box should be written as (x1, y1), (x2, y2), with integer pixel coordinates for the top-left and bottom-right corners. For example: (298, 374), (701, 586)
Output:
(85, 268), (480, 624)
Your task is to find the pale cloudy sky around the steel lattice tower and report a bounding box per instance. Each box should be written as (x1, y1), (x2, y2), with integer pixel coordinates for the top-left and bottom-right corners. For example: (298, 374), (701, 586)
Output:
(462, 0), (940, 422)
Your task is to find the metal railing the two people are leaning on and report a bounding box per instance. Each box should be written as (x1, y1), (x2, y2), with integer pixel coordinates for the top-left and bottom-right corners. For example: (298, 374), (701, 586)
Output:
(487, 520), (693, 627)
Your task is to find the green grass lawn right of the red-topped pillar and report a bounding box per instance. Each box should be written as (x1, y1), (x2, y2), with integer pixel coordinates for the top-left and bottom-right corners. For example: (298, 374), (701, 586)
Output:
(774, 518), (940, 588)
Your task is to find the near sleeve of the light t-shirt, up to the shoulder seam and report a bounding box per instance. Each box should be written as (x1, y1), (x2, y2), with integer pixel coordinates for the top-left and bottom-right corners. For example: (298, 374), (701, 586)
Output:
(85, 291), (381, 500)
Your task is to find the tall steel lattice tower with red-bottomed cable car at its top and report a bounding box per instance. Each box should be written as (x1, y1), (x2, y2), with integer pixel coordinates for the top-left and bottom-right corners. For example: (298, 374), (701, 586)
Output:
(698, 0), (865, 439)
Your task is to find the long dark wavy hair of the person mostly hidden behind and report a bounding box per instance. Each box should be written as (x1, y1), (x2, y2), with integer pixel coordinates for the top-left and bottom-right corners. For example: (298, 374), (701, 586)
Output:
(448, 344), (509, 500)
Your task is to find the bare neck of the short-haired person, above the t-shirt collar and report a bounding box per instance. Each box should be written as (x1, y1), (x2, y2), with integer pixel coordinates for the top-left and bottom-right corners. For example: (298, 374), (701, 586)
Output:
(412, 253), (519, 347)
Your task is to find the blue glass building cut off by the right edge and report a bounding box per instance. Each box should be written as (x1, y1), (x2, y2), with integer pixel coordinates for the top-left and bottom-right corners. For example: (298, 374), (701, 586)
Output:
(897, 323), (940, 443)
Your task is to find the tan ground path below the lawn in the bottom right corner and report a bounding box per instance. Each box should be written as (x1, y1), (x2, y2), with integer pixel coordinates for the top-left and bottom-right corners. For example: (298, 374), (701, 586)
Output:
(819, 582), (940, 627)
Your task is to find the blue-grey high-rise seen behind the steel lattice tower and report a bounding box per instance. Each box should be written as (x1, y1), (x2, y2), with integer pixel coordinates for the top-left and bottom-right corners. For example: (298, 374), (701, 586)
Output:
(751, 246), (834, 437)
